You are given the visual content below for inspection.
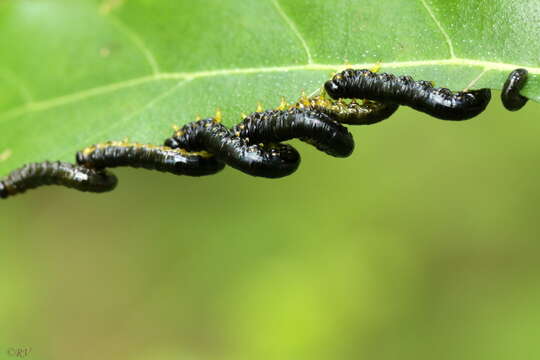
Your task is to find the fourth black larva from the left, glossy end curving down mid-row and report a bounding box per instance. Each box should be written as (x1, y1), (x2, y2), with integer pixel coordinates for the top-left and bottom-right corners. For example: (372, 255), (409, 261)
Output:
(232, 108), (354, 157)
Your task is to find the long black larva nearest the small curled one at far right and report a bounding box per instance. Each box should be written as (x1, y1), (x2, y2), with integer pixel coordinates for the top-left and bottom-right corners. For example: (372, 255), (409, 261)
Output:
(324, 69), (491, 120)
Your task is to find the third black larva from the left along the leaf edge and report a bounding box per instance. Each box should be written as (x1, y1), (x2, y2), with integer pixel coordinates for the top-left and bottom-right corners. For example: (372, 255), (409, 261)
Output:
(165, 118), (300, 178)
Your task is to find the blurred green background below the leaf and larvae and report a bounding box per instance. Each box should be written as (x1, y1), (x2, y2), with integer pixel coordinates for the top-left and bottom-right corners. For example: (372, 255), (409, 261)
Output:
(0, 99), (540, 360)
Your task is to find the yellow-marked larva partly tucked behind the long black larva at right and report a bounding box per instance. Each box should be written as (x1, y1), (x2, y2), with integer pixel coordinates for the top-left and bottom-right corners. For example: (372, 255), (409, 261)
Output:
(292, 95), (399, 125)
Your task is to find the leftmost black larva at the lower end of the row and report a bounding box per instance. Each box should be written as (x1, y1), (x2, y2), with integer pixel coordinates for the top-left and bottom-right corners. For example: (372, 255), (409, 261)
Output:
(0, 161), (118, 198)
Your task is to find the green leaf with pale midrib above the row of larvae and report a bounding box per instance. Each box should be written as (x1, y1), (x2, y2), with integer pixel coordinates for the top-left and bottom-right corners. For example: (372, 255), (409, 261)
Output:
(0, 0), (540, 175)
